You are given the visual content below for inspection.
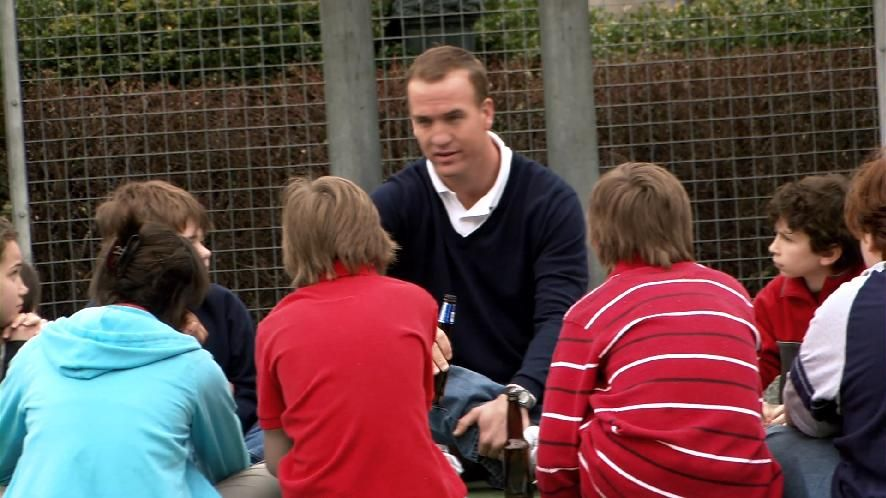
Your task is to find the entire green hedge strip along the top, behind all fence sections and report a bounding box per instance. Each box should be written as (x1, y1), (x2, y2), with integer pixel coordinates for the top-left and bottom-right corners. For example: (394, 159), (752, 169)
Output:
(18, 0), (872, 83)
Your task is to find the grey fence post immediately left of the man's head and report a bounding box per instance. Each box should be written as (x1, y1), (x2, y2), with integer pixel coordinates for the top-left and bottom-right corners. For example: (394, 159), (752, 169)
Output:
(320, 0), (382, 192)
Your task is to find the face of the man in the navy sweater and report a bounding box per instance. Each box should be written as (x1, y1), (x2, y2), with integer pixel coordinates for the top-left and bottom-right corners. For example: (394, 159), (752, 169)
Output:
(406, 69), (494, 180)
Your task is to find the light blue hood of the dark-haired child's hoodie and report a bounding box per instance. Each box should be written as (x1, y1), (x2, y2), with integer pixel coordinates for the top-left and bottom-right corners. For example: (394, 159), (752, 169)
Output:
(35, 306), (201, 379)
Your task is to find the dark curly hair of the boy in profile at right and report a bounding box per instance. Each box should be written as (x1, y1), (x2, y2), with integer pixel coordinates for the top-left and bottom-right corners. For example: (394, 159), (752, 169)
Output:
(767, 175), (861, 271)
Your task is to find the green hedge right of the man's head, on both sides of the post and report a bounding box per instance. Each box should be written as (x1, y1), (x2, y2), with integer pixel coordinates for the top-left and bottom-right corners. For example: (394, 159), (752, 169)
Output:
(478, 0), (873, 59)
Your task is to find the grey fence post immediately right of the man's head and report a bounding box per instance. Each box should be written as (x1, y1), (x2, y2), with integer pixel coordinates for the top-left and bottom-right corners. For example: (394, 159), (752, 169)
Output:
(538, 0), (605, 286)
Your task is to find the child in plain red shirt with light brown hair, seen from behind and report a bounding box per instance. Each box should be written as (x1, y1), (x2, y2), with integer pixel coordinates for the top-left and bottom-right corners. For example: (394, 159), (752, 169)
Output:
(256, 177), (467, 498)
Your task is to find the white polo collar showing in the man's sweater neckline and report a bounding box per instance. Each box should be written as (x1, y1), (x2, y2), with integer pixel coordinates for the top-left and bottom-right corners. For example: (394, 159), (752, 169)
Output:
(426, 131), (514, 237)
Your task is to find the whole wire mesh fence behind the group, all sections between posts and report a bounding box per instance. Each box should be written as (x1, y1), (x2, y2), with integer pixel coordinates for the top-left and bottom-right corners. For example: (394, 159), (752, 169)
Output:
(0, 0), (879, 317)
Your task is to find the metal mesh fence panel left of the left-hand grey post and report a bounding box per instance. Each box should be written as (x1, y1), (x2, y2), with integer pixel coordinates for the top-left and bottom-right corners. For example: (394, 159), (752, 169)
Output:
(17, 0), (327, 317)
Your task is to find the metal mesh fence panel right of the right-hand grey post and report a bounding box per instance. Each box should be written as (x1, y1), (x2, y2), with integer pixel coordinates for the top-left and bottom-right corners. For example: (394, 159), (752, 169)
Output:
(591, 0), (878, 293)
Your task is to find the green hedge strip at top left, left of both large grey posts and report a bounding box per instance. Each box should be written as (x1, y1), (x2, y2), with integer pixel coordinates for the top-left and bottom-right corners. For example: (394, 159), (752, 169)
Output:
(17, 0), (321, 82)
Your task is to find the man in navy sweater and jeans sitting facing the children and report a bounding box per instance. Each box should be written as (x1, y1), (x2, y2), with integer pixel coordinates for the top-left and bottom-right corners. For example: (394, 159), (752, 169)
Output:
(372, 46), (588, 480)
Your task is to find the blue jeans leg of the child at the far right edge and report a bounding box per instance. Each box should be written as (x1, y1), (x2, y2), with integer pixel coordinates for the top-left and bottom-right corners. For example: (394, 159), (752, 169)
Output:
(766, 425), (840, 498)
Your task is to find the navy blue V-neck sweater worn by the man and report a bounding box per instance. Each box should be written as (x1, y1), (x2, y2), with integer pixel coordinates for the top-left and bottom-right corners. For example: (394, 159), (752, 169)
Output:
(372, 154), (588, 400)
